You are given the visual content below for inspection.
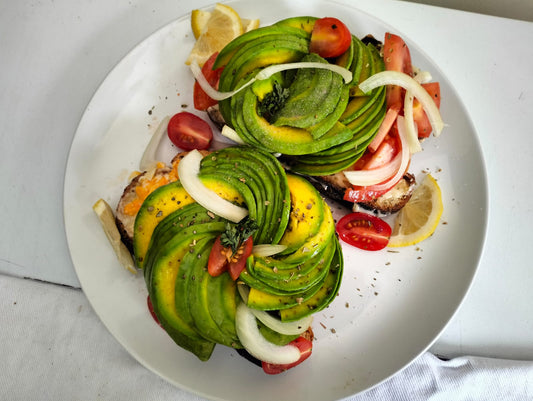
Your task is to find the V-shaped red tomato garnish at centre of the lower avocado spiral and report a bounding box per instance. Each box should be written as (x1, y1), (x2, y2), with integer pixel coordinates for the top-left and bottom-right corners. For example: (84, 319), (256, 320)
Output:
(207, 235), (254, 281)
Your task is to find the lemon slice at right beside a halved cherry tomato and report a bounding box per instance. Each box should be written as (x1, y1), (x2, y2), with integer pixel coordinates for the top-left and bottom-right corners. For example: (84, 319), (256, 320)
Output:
(389, 174), (443, 247)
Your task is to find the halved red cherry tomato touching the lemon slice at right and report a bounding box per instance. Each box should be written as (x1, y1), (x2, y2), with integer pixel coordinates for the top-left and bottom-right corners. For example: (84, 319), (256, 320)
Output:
(337, 212), (392, 251)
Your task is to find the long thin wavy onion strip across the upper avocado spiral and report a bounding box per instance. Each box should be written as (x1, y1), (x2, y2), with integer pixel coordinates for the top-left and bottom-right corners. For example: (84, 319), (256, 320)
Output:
(190, 60), (352, 100)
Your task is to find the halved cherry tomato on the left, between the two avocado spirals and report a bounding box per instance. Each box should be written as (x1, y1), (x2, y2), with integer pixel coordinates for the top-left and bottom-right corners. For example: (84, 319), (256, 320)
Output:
(167, 111), (213, 150)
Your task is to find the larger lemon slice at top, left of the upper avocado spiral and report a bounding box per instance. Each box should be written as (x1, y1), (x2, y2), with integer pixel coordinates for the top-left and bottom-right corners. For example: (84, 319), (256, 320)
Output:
(185, 3), (243, 66)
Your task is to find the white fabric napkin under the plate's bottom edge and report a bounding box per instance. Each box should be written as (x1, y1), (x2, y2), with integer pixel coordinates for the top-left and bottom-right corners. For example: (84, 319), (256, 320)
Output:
(0, 275), (533, 401)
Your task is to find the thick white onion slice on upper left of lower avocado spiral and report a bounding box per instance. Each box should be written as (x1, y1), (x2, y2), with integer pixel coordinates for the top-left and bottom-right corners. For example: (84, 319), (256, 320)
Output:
(178, 150), (248, 223)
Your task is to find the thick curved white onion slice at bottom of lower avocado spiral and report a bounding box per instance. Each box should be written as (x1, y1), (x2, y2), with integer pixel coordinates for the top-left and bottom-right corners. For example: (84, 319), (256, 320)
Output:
(235, 302), (300, 365)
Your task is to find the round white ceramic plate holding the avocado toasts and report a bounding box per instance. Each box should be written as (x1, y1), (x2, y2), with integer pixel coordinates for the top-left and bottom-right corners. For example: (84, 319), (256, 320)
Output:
(64, 0), (487, 401)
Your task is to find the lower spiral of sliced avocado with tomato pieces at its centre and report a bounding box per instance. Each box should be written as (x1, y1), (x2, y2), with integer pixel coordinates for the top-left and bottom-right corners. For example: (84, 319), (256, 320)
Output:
(133, 146), (343, 360)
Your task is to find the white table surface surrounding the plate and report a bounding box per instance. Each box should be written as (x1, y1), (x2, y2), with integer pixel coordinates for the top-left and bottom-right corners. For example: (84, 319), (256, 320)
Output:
(0, 0), (533, 396)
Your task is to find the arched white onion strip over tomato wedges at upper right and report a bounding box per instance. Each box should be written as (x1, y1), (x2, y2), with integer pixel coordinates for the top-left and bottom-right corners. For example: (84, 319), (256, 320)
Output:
(359, 71), (444, 136)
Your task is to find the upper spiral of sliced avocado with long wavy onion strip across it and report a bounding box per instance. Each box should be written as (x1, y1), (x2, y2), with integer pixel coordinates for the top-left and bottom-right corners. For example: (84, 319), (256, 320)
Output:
(214, 17), (386, 176)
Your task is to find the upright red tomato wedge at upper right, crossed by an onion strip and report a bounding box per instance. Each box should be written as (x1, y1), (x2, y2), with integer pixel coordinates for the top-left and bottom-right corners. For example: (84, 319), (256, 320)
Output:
(383, 32), (413, 107)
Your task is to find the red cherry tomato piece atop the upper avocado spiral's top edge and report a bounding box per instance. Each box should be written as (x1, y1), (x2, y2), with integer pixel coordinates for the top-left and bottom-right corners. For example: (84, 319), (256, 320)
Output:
(309, 17), (352, 58)
